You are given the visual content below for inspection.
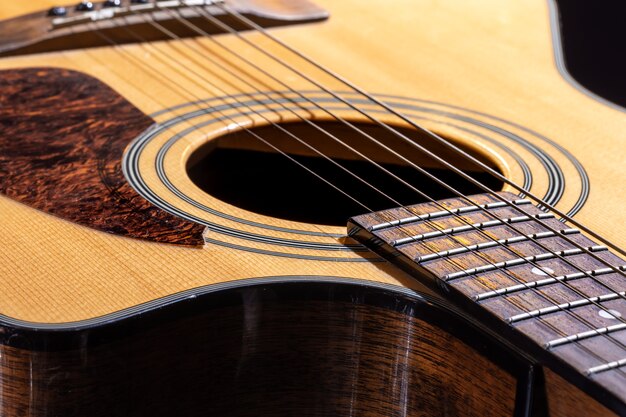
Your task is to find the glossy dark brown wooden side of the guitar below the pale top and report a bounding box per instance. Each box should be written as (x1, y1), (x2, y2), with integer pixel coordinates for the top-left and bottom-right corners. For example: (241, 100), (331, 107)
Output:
(0, 279), (528, 417)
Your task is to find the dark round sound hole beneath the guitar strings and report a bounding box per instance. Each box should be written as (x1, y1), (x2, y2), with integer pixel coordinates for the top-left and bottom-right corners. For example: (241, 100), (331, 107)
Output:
(187, 122), (503, 226)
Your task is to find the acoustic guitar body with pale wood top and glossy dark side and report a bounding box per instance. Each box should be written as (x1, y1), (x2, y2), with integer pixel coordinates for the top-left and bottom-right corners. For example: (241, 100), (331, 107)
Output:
(0, 0), (626, 417)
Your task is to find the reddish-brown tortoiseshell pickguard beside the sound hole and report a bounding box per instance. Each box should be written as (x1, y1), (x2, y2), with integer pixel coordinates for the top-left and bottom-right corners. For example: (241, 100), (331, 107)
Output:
(0, 68), (204, 246)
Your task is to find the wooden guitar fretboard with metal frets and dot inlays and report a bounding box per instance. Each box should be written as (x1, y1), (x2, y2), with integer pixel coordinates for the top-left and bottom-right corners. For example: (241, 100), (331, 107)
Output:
(349, 193), (626, 398)
